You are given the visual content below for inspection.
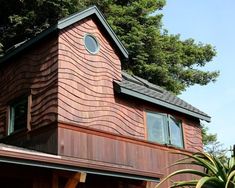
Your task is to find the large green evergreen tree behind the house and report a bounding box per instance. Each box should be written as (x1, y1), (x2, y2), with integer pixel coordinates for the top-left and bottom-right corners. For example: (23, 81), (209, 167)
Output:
(0, 0), (219, 94)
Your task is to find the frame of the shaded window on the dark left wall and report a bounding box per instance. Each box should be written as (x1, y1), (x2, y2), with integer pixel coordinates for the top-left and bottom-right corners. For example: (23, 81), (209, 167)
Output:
(7, 95), (32, 136)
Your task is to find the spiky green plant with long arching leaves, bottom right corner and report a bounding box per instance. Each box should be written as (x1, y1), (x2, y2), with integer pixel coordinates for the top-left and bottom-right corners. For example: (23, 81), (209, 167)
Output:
(156, 151), (235, 188)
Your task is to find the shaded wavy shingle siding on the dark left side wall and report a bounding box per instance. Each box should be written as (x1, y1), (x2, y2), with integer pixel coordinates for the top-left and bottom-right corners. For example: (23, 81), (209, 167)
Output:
(0, 38), (58, 136)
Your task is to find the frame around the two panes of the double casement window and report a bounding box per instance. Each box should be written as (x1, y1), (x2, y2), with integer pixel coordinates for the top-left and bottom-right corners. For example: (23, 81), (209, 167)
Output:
(145, 110), (185, 149)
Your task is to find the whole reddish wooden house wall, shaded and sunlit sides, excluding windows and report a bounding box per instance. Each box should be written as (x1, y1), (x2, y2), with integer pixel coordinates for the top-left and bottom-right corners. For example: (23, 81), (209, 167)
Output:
(0, 14), (202, 187)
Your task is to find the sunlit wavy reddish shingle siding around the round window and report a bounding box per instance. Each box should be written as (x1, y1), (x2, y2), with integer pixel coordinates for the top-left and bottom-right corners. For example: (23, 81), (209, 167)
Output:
(58, 18), (144, 138)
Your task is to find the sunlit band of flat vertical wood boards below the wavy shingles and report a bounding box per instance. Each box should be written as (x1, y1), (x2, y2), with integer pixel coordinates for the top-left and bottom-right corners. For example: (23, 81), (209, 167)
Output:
(58, 124), (200, 187)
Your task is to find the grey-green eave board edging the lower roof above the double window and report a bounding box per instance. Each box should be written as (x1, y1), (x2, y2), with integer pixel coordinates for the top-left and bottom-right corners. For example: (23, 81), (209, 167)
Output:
(114, 82), (211, 122)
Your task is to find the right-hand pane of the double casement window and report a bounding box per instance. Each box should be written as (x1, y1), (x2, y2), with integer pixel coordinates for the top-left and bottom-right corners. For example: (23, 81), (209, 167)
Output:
(169, 117), (183, 148)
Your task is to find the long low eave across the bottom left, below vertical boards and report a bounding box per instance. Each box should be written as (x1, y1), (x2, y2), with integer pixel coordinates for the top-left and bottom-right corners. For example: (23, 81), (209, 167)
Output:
(0, 147), (162, 182)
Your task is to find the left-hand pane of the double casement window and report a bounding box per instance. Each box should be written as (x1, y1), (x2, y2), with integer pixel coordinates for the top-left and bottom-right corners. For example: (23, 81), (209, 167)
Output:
(147, 113), (166, 143)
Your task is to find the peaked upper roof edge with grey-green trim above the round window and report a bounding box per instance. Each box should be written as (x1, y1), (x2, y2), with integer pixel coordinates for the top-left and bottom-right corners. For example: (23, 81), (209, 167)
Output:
(0, 6), (128, 63)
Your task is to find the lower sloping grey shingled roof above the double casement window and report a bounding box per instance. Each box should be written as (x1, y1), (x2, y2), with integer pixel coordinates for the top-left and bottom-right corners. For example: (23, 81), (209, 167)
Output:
(114, 72), (211, 122)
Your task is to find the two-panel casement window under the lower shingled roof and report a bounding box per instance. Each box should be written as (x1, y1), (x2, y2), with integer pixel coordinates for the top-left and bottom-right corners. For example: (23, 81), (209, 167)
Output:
(146, 112), (183, 148)
